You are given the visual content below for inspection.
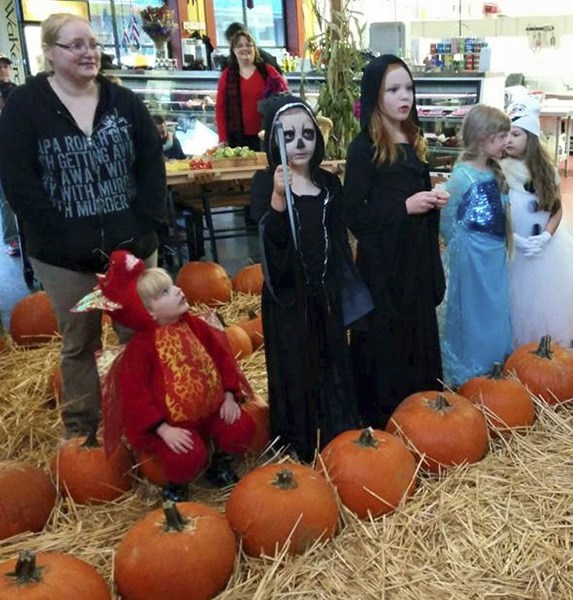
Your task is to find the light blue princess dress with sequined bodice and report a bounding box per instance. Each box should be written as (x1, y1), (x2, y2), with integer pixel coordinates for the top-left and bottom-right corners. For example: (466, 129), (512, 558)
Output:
(440, 163), (512, 388)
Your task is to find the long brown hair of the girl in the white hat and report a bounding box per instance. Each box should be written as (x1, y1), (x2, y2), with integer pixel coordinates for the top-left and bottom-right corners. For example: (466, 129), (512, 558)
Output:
(524, 130), (561, 214)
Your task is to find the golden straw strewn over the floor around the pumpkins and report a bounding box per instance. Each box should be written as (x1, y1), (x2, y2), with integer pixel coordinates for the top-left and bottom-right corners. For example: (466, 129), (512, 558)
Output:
(0, 297), (573, 600)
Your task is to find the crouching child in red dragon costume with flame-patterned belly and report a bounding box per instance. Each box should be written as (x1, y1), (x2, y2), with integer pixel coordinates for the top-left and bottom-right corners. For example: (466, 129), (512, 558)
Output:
(76, 250), (255, 501)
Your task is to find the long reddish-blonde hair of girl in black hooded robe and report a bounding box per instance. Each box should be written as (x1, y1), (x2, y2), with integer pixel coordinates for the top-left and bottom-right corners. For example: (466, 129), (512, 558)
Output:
(368, 64), (426, 166)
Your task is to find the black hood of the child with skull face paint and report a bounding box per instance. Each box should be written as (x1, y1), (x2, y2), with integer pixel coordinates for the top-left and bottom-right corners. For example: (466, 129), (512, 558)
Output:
(261, 94), (324, 176)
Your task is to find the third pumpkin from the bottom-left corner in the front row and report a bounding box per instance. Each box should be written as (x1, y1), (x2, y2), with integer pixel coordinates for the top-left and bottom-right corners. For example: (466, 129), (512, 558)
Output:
(226, 463), (338, 556)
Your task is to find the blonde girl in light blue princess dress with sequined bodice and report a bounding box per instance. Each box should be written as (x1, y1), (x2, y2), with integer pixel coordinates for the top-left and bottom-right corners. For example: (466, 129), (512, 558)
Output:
(440, 104), (513, 388)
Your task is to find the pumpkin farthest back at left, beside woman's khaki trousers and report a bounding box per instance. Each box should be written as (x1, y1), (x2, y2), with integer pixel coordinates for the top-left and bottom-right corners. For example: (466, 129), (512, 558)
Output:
(10, 291), (58, 347)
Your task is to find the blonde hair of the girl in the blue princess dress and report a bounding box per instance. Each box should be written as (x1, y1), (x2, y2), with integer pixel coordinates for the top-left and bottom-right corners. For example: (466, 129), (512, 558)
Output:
(458, 104), (511, 194)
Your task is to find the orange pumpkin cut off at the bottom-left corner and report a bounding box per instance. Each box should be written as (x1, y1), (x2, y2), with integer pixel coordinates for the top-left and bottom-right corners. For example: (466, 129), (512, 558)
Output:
(0, 550), (111, 600)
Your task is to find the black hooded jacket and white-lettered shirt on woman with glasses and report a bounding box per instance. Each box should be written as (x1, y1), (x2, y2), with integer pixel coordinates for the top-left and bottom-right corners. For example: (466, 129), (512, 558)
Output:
(0, 74), (167, 272)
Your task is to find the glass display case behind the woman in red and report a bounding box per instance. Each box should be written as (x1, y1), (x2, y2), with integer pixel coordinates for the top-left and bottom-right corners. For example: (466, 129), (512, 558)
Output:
(111, 69), (322, 155)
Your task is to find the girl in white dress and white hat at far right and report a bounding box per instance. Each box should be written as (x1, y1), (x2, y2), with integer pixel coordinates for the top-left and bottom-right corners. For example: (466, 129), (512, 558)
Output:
(500, 92), (573, 347)
